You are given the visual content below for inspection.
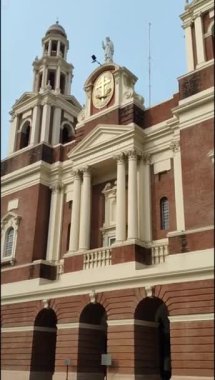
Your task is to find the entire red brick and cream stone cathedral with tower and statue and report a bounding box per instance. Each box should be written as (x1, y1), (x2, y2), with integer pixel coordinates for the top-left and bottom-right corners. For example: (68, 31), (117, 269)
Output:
(1, 0), (214, 380)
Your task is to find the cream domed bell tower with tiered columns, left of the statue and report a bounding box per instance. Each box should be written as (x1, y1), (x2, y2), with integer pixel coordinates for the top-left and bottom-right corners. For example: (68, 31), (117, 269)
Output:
(9, 22), (81, 154)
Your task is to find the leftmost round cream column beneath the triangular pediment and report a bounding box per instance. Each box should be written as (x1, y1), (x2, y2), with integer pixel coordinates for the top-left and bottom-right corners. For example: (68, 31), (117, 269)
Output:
(69, 170), (81, 252)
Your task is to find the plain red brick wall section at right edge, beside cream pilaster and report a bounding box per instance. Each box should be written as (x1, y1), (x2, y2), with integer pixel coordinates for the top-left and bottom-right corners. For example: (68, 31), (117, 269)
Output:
(181, 119), (214, 229)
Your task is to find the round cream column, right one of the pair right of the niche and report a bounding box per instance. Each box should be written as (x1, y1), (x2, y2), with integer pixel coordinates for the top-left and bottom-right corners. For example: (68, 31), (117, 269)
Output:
(128, 151), (138, 239)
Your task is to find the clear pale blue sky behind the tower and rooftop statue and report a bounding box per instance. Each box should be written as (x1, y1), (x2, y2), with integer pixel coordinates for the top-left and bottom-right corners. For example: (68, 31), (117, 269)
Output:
(1, 0), (186, 158)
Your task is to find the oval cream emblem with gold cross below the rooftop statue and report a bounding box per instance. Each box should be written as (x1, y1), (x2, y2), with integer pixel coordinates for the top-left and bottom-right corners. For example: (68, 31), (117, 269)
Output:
(92, 71), (114, 109)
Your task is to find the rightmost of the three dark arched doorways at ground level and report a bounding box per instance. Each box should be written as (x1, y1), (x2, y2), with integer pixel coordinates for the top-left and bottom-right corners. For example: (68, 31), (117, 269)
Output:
(134, 297), (171, 380)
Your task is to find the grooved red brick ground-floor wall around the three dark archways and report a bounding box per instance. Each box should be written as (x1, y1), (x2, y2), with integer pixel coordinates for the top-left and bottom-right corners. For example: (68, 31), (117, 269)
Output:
(2, 280), (214, 376)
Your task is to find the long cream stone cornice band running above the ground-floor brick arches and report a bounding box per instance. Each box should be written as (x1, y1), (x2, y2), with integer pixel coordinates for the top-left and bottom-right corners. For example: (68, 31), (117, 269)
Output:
(2, 250), (214, 305)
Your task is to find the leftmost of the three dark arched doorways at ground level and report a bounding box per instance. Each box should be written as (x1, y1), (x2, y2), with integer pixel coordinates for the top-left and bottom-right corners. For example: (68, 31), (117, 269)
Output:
(29, 309), (57, 380)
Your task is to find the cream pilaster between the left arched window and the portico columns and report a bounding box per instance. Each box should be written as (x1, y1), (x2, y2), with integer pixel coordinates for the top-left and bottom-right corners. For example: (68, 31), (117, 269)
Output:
(46, 184), (64, 261)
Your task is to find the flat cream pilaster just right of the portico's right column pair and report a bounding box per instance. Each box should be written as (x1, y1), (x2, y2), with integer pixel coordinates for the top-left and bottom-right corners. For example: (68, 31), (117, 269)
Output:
(141, 154), (152, 242)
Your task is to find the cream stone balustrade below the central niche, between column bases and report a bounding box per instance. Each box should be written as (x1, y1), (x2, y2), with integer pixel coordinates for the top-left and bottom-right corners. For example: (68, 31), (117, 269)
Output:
(84, 248), (111, 269)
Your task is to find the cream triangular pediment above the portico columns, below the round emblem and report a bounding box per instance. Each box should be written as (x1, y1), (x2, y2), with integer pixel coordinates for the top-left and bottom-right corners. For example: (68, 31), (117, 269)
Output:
(68, 124), (132, 158)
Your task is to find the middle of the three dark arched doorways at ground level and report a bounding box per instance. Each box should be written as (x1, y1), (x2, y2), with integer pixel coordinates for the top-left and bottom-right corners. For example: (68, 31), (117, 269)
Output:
(77, 303), (107, 380)
